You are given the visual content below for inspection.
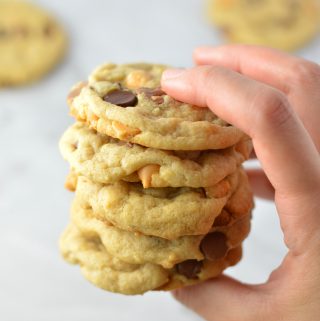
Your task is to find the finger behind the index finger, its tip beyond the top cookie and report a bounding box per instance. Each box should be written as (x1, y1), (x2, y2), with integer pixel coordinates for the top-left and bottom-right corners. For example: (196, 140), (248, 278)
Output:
(193, 45), (320, 151)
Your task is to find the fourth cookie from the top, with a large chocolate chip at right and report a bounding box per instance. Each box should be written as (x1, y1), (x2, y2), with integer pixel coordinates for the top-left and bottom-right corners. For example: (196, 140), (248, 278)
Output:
(71, 199), (250, 268)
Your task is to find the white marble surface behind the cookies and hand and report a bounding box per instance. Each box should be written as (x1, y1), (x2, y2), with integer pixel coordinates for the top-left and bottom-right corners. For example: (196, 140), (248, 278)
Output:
(0, 0), (320, 321)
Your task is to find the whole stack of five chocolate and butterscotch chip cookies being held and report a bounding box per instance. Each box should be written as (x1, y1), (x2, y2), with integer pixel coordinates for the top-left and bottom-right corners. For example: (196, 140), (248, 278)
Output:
(60, 64), (253, 294)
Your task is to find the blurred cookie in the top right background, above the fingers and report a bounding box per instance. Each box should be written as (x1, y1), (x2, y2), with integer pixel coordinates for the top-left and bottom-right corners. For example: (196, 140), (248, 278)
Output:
(207, 0), (320, 51)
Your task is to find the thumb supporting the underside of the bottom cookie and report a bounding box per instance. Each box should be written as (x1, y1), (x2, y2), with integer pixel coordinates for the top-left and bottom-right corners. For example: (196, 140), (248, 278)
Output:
(172, 275), (271, 321)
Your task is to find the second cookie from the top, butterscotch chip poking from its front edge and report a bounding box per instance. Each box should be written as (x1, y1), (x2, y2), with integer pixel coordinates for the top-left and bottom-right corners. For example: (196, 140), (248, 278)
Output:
(60, 122), (252, 188)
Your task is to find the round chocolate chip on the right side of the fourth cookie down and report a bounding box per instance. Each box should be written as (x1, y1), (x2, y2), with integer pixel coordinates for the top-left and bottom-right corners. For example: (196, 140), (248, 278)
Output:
(200, 232), (228, 261)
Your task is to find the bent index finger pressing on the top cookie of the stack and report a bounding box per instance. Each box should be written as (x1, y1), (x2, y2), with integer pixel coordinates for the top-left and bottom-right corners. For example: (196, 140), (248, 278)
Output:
(161, 66), (320, 195)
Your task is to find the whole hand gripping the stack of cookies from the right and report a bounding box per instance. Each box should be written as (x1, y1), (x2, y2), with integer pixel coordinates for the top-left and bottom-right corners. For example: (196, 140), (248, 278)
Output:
(162, 45), (320, 321)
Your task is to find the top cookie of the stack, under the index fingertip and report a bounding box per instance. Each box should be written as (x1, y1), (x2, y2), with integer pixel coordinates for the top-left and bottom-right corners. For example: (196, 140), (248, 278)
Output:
(68, 64), (245, 151)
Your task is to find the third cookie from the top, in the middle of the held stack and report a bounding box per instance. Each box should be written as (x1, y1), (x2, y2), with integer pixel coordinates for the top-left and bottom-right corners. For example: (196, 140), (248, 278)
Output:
(72, 168), (252, 240)
